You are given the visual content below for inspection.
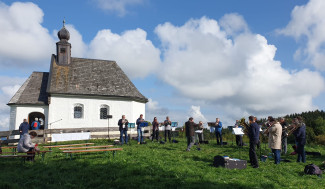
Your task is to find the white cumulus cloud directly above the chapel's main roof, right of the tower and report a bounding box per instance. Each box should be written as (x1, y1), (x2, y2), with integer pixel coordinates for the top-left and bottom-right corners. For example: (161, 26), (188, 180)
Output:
(88, 29), (160, 78)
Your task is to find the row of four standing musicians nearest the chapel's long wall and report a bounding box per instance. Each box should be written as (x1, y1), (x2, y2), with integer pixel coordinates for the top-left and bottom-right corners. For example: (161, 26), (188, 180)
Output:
(118, 114), (172, 144)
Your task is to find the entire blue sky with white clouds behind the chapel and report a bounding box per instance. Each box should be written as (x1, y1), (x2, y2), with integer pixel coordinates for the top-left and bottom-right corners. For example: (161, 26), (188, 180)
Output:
(0, 0), (325, 130)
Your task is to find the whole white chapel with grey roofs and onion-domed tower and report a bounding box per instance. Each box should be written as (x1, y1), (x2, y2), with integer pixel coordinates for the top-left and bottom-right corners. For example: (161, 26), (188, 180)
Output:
(8, 24), (148, 130)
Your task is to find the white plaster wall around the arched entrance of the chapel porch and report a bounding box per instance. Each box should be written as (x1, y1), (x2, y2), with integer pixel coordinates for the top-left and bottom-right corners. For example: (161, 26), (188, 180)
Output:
(9, 106), (48, 130)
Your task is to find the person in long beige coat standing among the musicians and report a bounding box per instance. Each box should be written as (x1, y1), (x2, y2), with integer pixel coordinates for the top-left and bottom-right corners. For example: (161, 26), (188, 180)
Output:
(266, 117), (282, 164)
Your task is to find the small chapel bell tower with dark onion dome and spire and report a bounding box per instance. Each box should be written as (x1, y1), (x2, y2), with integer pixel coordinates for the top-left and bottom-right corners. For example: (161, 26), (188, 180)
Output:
(56, 20), (71, 65)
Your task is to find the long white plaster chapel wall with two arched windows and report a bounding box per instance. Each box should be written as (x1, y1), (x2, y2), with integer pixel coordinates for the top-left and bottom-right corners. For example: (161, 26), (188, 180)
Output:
(49, 96), (145, 129)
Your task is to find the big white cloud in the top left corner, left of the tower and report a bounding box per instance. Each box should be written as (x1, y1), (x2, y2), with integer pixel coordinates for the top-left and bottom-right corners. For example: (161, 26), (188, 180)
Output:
(0, 2), (55, 67)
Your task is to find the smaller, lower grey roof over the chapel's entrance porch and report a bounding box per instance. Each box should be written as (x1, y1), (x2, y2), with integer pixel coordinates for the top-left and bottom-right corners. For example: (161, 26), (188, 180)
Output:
(8, 72), (49, 105)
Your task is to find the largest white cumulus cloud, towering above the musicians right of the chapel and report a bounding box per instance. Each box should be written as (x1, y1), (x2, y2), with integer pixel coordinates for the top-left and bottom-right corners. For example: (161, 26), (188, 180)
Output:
(155, 14), (324, 119)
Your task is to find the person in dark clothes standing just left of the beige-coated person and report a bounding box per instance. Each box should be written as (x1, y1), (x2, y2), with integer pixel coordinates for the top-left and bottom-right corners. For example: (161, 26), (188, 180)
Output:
(248, 116), (260, 168)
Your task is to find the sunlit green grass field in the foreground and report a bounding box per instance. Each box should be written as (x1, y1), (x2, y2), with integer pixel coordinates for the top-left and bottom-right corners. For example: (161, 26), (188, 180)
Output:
(0, 138), (325, 189)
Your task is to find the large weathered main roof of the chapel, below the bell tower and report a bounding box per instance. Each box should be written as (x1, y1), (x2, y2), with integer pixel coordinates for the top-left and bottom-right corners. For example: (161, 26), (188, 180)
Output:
(47, 55), (148, 102)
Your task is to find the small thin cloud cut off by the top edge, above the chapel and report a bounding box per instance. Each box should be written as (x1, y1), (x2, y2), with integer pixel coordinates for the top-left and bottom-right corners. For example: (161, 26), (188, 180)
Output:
(94, 0), (144, 16)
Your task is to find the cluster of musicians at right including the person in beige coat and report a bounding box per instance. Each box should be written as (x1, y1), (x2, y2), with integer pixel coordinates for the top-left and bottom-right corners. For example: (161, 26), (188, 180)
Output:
(248, 116), (306, 168)
